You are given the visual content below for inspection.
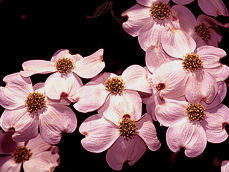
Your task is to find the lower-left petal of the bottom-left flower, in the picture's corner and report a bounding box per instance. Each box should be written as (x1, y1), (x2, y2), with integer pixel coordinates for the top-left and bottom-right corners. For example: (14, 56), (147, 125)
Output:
(0, 156), (22, 172)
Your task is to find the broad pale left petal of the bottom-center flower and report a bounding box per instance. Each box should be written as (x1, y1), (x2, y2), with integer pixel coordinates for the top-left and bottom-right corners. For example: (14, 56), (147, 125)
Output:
(79, 114), (120, 153)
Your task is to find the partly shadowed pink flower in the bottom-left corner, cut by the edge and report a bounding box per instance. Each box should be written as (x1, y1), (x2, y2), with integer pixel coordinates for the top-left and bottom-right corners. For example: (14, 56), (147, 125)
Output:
(0, 131), (59, 172)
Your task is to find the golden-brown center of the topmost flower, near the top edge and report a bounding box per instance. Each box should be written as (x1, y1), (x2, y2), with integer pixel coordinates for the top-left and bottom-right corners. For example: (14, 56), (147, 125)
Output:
(150, 2), (171, 20)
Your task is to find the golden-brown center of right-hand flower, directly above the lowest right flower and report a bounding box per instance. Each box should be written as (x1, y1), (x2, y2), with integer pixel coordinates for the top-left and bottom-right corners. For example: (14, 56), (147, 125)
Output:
(182, 53), (203, 71)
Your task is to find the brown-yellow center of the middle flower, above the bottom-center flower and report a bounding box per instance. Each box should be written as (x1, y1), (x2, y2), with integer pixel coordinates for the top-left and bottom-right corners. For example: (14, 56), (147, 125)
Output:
(104, 77), (124, 95)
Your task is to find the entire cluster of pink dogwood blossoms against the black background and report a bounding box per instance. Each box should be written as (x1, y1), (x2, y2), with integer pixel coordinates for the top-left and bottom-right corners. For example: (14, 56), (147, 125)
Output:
(0, 0), (229, 172)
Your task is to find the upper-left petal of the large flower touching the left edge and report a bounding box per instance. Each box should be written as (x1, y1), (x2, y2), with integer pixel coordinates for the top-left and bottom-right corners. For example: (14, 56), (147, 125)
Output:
(0, 73), (33, 109)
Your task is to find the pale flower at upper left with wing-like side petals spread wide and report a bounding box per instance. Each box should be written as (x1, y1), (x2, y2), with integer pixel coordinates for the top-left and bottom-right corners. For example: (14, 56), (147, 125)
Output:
(20, 49), (105, 101)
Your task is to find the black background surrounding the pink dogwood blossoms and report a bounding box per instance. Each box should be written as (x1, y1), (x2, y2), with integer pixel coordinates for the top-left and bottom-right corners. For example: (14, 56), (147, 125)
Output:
(0, 0), (229, 172)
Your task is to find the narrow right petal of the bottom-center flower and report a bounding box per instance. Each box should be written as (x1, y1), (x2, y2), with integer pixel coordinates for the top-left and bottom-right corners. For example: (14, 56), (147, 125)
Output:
(137, 113), (161, 151)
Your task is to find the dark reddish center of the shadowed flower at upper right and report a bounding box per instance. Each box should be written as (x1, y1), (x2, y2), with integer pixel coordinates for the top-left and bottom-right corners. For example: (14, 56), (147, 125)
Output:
(194, 23), (211, 41)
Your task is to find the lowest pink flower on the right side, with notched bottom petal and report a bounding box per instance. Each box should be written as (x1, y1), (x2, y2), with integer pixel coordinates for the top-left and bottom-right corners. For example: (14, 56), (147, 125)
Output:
(155, 82), (229, 157)
